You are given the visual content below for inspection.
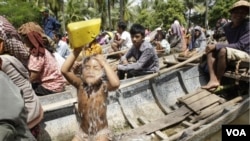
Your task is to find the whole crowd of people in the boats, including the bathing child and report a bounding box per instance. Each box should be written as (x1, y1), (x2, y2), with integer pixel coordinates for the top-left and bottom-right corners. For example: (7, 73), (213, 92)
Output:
(0, 1), (250, 141)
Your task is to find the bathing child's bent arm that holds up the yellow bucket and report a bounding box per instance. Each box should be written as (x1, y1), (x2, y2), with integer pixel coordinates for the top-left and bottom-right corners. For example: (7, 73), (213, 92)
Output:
(61, 48), (82, 88)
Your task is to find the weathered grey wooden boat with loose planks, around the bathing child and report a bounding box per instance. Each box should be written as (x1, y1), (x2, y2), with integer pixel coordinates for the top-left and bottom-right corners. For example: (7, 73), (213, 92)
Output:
(39, 54), (250, 141)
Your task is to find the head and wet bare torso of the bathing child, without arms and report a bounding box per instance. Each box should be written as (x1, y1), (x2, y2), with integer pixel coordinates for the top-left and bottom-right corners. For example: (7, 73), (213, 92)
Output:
(78, 59), (108, 135)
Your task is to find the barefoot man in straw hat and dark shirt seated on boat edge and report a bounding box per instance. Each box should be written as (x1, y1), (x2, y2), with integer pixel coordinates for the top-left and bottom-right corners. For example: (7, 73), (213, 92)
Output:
(202, 0), (250, 90)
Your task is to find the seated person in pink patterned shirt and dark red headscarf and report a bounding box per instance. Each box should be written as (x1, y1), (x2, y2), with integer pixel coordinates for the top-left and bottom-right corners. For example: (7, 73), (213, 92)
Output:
(19, 24), (66, 96)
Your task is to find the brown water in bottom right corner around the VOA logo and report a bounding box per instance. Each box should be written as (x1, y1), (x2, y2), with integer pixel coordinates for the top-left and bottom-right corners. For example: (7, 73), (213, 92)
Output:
(204, 110), (250, 141)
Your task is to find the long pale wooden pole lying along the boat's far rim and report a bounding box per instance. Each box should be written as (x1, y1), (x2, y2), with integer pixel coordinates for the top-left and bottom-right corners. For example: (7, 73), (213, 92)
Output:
(120, 53), (203, 89)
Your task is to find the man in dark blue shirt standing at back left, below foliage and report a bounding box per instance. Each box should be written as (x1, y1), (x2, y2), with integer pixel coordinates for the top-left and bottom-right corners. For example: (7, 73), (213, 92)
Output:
(41, 8), (61, 39)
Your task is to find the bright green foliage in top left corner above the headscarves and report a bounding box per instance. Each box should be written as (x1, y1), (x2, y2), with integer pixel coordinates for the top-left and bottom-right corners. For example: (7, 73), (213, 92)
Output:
(0, 0), (41, 28)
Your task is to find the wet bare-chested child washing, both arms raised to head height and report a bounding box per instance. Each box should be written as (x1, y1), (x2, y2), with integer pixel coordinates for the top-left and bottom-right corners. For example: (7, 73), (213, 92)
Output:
(61, 48), (120, 141)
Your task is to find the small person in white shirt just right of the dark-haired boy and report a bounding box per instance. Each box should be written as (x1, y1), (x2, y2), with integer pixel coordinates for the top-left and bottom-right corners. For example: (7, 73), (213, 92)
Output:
(153, 28), (170, 55)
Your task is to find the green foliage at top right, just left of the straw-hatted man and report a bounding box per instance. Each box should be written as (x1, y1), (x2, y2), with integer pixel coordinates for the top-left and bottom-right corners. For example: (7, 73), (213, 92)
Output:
(208, 0), (237, 28)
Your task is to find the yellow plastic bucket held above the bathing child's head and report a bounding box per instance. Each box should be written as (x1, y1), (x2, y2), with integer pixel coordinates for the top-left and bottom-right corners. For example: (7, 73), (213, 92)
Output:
(67, 19), (101, 48)
